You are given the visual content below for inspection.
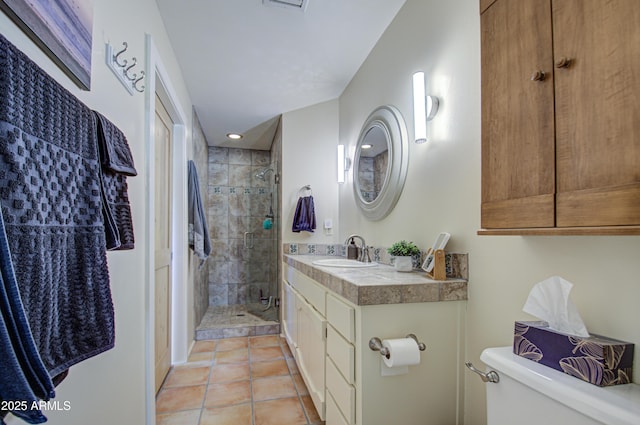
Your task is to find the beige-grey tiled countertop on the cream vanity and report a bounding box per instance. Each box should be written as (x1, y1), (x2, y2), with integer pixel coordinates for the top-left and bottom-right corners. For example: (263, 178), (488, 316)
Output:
(284, 254), (467, 306)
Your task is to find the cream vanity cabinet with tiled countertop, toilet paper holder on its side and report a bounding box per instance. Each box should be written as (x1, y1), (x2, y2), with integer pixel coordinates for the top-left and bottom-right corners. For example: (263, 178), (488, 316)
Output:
(282, 256), (466, 425)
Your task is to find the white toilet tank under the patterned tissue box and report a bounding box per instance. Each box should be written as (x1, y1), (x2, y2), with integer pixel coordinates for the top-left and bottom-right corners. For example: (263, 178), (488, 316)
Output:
(480, 347), (640, 425)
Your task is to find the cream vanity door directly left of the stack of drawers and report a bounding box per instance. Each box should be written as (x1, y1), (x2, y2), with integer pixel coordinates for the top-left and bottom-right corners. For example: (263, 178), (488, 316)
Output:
(296, 297), (327, 420)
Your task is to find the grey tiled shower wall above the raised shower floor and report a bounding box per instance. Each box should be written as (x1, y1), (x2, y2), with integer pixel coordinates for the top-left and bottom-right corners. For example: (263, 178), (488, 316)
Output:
(207, 147), (278, 306)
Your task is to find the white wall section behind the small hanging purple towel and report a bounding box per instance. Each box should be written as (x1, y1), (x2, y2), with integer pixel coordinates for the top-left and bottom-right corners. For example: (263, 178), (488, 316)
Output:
(281, 100), (338, 244)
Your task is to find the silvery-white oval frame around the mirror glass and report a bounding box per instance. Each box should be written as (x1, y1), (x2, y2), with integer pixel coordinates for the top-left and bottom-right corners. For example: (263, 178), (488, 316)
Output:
(353, 105), (409, 221)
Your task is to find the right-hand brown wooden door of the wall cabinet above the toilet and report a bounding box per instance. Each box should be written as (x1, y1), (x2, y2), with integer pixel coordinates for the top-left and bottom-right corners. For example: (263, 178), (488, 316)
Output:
(553, 0), (640, 227)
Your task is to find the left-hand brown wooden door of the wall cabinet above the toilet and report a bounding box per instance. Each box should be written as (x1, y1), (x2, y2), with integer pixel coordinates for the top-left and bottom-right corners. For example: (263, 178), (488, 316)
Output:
(481, 0), (556, 229)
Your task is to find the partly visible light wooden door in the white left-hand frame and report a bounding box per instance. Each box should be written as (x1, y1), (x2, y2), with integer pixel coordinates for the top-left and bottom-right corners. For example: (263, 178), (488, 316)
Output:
(154, 96), (173, 393)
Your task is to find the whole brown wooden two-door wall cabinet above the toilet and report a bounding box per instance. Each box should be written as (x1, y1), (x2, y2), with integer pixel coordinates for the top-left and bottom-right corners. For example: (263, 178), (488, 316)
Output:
(478, 0), (640, 235)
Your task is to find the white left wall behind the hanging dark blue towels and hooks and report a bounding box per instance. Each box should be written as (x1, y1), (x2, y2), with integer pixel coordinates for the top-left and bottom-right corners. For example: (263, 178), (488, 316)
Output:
(0, 0), (193, 425)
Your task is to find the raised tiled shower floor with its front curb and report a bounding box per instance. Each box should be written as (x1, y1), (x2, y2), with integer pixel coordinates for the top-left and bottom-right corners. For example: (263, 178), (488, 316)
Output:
(196, 304), (280, 341)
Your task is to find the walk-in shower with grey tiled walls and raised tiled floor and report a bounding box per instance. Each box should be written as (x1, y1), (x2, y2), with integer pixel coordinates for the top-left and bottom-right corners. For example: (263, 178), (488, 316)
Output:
(196, 148), (281, 339)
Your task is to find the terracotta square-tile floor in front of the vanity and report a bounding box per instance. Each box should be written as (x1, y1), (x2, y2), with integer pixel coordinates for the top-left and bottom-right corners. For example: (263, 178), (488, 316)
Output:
(156, 335), (324, 425)
